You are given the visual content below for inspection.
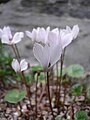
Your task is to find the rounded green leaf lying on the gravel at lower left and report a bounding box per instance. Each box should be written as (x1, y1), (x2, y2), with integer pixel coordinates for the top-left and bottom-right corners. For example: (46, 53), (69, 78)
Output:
(4, 89), (27, 103)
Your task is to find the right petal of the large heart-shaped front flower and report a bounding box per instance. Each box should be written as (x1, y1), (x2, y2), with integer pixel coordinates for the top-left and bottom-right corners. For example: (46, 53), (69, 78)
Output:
(50, 44), (62, 67)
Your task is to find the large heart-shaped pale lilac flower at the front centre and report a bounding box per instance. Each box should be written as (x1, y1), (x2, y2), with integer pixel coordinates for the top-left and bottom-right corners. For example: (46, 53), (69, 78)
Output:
(33, 43), (61, 71)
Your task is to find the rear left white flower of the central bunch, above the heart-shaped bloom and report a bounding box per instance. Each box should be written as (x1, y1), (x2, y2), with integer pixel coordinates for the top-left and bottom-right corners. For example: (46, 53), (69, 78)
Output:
(26, 27), (50, 44)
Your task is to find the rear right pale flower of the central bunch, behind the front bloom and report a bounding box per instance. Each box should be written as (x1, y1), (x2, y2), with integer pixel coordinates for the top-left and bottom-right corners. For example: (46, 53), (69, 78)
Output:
(48, 25), (79, 49)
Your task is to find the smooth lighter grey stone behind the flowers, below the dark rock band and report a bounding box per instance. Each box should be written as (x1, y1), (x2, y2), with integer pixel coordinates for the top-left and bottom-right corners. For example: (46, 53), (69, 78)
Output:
(0, 0), (90, 70)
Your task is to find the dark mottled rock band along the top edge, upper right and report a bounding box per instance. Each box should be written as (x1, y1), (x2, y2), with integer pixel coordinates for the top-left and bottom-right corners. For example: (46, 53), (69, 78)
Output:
(21, 0), (90, 18)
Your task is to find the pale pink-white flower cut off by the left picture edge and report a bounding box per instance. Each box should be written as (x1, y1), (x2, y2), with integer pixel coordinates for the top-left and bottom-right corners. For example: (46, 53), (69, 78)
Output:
(0, 27), (24, 45)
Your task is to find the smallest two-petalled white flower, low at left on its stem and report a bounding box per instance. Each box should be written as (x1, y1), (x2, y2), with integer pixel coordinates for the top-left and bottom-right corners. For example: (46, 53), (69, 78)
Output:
(12, 59), (28, 72)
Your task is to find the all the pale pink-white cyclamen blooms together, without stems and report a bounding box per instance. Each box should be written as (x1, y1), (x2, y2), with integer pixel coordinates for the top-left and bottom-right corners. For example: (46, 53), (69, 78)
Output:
(0, 25), (79, 72)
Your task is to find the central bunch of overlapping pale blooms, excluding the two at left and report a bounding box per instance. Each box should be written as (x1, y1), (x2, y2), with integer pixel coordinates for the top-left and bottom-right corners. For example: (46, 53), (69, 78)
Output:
(26, 27), (78, 71)
